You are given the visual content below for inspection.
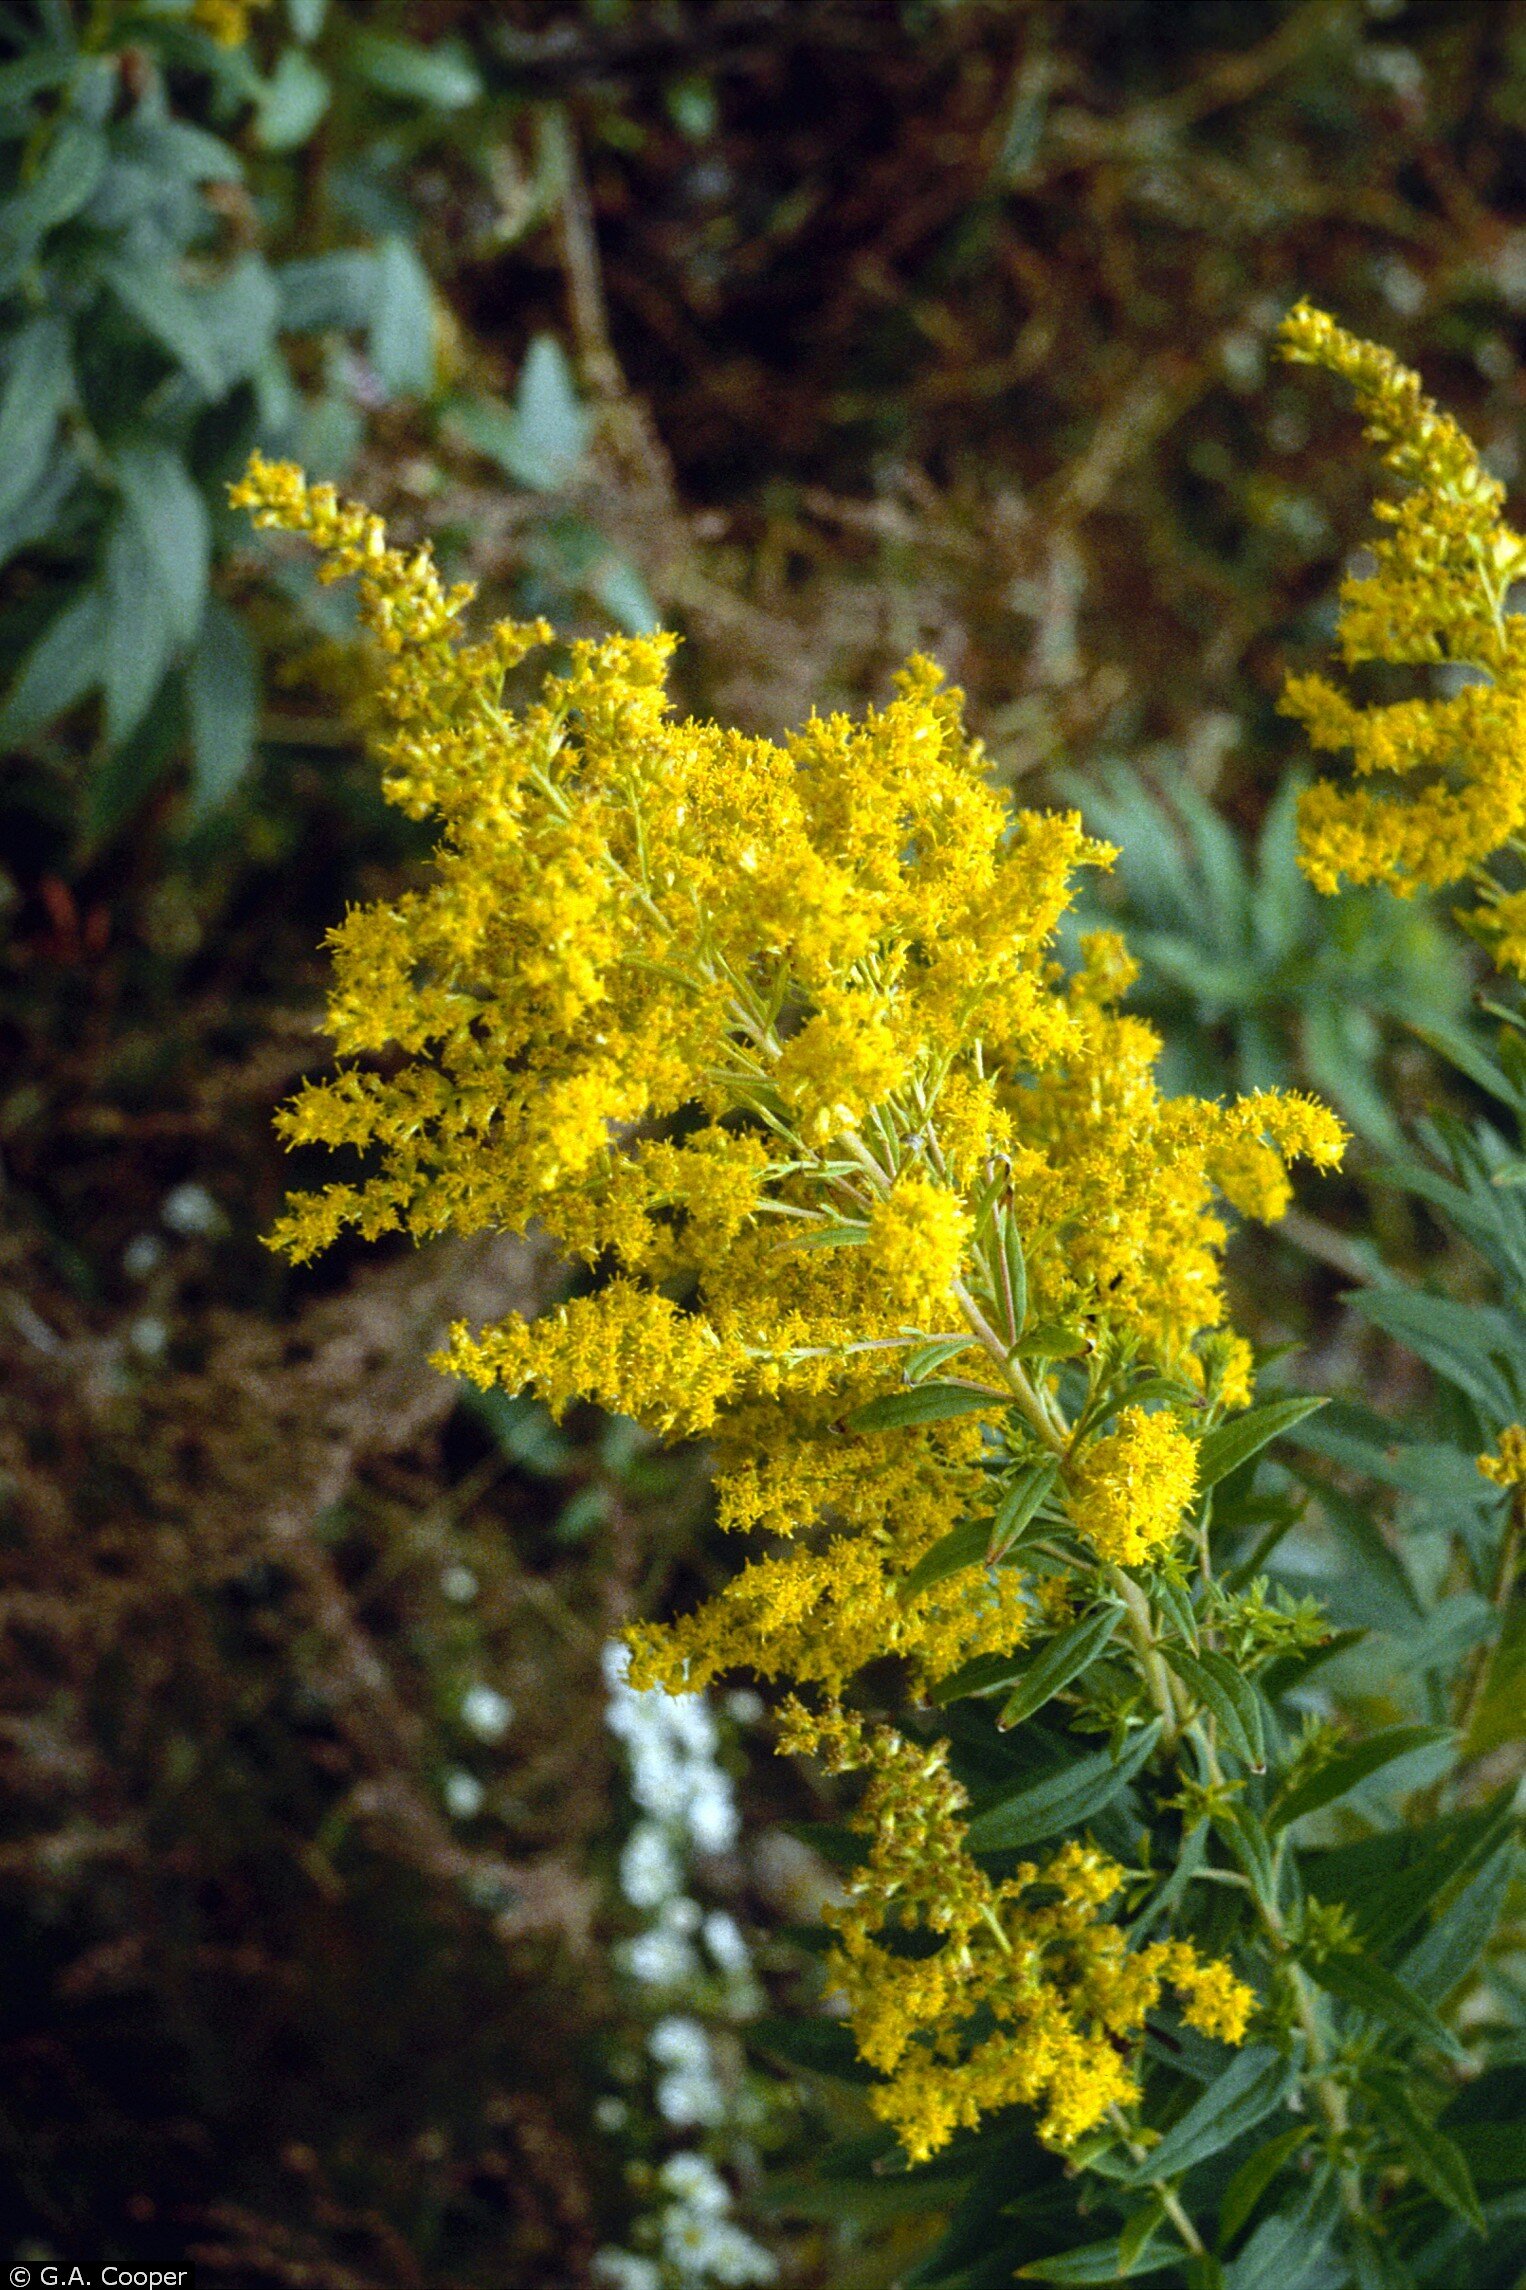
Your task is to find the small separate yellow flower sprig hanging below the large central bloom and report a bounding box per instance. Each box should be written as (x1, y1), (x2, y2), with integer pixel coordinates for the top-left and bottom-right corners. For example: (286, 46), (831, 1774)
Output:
(784, 1704), (1256, 2162)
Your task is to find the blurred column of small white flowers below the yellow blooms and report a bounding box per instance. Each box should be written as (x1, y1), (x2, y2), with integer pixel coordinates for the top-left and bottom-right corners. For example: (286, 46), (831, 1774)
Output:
(593, 1647), (779, 2290)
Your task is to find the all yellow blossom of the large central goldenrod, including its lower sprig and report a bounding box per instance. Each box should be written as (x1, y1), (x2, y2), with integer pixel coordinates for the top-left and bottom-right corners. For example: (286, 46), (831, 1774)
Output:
(234, 460), (1340, 2153)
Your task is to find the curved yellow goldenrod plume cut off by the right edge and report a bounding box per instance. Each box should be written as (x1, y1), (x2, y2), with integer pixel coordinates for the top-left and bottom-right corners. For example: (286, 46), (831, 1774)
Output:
(1281, 302), (1526, 976)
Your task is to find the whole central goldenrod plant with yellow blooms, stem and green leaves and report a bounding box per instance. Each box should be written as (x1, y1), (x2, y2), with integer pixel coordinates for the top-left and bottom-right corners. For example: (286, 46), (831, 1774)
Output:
(234, 403), (1515, 2290)
